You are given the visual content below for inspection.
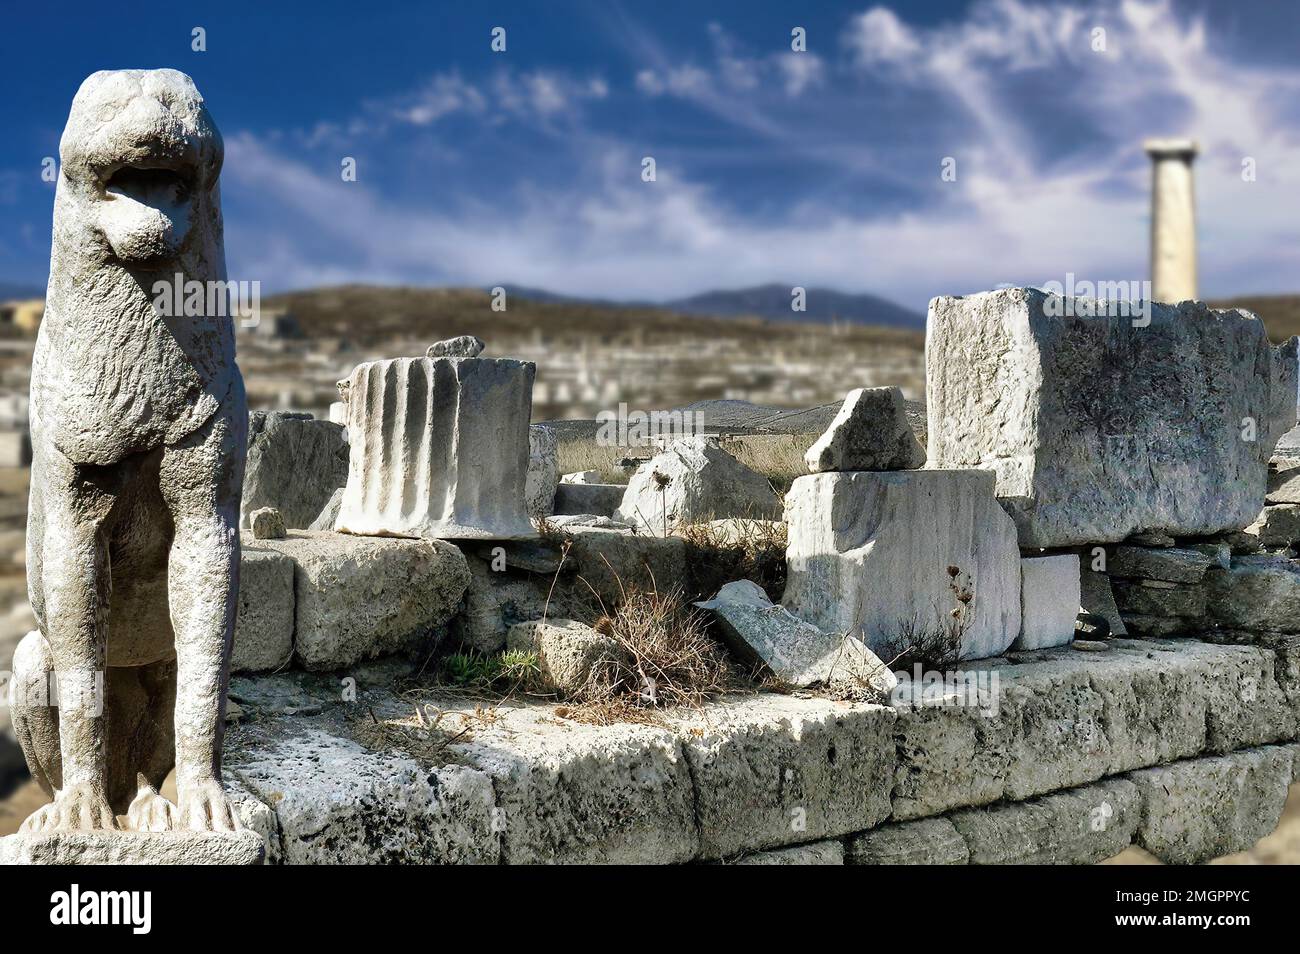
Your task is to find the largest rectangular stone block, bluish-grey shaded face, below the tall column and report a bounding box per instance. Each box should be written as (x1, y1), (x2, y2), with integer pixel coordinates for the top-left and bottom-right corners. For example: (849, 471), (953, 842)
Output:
(926, 289), (1296, 547)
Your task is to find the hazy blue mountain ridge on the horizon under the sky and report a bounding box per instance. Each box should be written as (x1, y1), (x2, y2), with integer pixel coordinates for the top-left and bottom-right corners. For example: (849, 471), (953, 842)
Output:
(506, 285), (926, 329)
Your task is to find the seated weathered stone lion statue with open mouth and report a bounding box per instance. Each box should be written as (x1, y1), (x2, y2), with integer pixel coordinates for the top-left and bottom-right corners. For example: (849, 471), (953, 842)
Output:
(10, 70), (248, 832)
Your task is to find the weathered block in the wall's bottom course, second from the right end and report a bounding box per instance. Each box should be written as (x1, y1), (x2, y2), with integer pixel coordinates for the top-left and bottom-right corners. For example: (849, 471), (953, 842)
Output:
(949, 779), (1141, 864)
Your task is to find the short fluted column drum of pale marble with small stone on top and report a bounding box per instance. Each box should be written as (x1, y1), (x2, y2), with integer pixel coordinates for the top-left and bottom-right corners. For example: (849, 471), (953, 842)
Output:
(334, 357), (537, 539)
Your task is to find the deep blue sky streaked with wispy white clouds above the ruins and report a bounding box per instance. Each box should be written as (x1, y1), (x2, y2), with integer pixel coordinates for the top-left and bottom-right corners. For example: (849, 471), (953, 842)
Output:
(0, 0), (1300, 309)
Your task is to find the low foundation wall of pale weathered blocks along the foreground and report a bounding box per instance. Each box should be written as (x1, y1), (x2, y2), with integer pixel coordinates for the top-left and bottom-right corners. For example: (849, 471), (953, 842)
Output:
(218, 639), (1300, 864)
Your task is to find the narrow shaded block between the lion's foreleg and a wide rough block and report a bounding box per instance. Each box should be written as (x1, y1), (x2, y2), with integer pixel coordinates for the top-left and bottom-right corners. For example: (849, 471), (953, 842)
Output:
(230, 532), (294, 672)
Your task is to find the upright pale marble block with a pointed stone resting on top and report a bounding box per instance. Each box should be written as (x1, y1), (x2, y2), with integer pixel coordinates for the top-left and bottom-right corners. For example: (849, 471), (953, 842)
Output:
(783, 471), (1021, 659)
